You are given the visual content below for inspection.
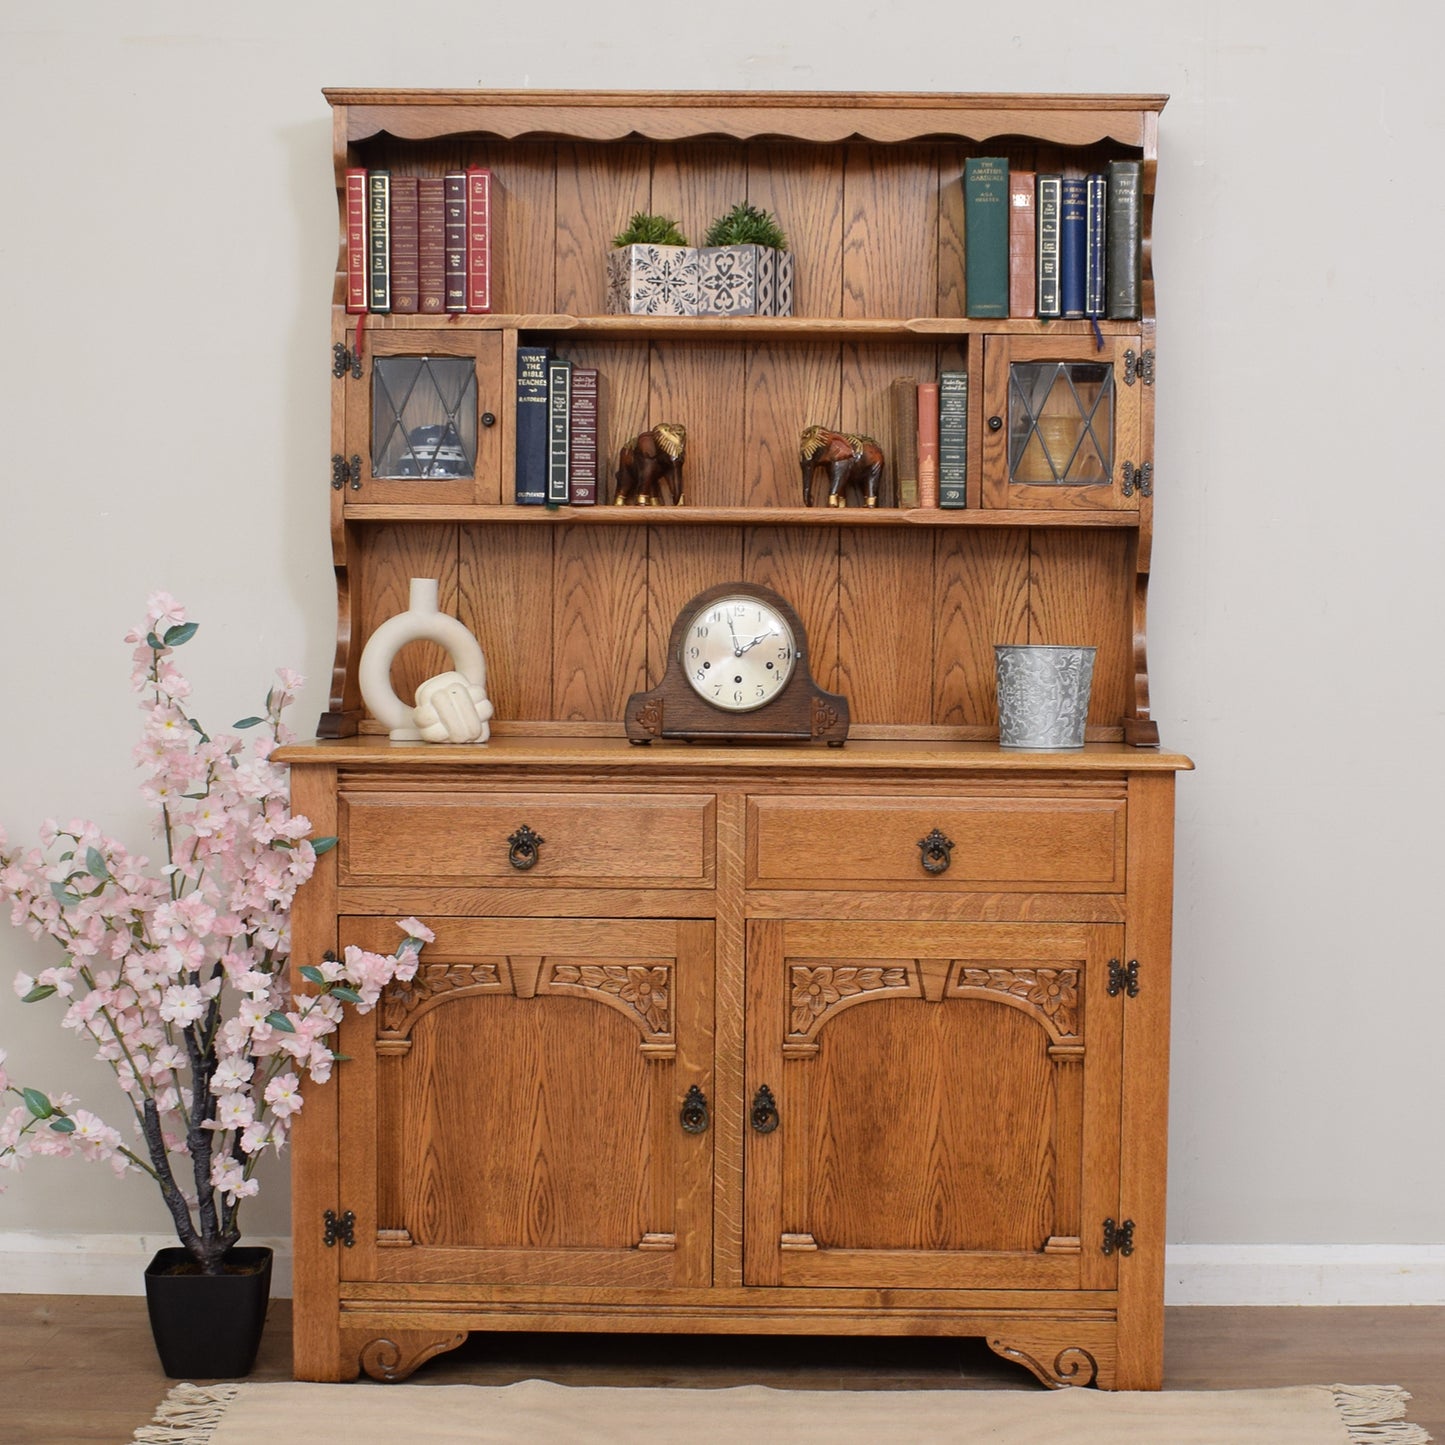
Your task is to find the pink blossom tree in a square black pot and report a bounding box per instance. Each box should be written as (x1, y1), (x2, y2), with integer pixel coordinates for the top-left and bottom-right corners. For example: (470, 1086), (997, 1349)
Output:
(0, 592), (432, 1379)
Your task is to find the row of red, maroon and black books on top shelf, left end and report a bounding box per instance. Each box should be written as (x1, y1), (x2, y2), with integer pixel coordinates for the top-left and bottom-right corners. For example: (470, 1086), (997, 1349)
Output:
(347, 166), (491, 315)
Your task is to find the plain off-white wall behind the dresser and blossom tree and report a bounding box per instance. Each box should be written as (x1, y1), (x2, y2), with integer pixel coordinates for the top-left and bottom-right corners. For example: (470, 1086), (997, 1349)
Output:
(0, 0), (1445, 1289)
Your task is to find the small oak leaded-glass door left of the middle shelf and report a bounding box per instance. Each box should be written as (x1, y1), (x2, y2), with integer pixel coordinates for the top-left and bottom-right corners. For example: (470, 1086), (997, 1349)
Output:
(344, 327), (514, 504)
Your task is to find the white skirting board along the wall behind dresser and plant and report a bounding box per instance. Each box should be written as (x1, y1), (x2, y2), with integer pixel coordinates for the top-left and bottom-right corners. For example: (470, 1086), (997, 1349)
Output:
(0, 1230), (1445, 1305)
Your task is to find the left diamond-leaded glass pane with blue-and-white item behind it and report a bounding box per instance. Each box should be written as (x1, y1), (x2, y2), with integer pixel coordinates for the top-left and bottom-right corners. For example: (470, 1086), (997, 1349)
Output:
(371, 357), (477, 478)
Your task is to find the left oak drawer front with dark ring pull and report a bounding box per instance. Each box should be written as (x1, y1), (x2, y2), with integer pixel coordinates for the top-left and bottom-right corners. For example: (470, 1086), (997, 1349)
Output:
(338, 790), (714, 887)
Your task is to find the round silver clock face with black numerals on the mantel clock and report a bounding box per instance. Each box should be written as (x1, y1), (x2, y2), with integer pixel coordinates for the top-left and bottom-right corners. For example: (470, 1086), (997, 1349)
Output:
(678, 597), (798, 712)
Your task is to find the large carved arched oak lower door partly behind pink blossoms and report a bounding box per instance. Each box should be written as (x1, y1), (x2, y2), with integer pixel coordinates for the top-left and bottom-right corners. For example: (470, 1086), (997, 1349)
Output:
(338, 918), (712, 1289)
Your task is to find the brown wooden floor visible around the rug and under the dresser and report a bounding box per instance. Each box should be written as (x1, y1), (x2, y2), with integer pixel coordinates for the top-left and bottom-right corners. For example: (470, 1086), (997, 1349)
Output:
(0, 1295), (1445, 1445)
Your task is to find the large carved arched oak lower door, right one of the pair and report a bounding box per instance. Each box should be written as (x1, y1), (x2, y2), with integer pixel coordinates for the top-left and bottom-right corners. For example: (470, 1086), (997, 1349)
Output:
(744, 920), (1123, 1289)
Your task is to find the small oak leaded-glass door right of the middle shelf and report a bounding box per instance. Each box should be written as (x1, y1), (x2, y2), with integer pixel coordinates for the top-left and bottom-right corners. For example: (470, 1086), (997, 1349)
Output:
(983, 337), (1149, 510)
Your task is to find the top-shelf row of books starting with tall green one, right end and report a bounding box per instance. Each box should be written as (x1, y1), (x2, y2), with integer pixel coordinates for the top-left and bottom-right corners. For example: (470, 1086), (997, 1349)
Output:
(964, 156), (1142, 321)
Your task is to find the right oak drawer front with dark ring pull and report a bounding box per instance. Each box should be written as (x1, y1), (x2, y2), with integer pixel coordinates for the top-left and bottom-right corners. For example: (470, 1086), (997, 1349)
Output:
(747, 796), (1124, 893)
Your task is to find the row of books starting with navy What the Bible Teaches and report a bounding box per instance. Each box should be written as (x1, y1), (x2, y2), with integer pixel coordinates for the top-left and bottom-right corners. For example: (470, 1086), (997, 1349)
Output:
(516, 347), (607, 507)
